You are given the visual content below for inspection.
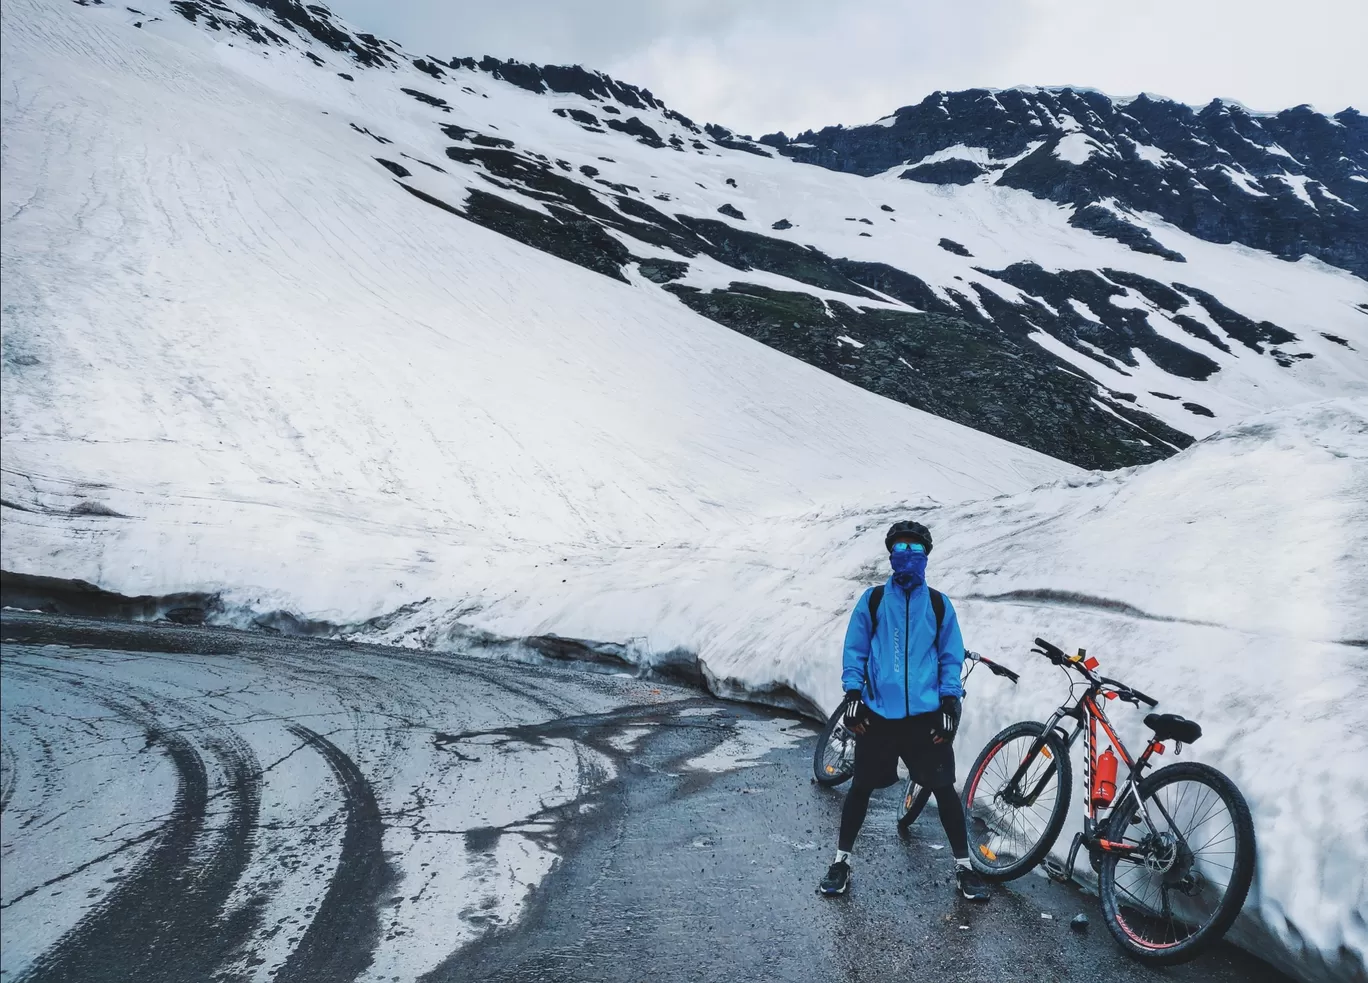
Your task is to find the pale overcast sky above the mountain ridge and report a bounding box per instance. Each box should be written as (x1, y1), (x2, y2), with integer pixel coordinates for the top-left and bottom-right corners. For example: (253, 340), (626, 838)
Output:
(330, 0), (1368, 135)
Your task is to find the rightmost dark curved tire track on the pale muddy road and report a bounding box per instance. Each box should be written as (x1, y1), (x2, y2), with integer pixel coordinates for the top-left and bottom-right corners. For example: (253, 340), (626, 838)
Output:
(275, 723), (397, 983)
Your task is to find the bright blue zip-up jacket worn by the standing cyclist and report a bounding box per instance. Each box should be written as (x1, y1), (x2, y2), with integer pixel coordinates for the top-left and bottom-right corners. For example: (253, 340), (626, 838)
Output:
(841, 577), (964, 719)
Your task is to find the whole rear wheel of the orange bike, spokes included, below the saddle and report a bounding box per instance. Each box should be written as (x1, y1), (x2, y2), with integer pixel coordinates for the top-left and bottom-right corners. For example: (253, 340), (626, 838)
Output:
(1099, 762), (1254, 965)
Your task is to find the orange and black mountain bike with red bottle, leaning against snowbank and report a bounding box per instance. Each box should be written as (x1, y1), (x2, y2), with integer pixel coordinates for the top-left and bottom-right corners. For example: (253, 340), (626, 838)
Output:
(963, 638), (1254, 964)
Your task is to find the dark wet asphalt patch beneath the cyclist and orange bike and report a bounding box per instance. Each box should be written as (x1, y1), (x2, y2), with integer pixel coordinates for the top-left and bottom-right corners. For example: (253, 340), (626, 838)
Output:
(435, 711), (1287, 983)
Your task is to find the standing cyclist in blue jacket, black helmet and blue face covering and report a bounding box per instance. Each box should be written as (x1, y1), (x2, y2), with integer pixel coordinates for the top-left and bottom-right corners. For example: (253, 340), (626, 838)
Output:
(818, 521), (988, 901)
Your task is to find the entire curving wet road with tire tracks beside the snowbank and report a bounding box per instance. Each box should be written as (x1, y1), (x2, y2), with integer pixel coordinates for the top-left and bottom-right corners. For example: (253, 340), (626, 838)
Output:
(0, 612), (1279, 983)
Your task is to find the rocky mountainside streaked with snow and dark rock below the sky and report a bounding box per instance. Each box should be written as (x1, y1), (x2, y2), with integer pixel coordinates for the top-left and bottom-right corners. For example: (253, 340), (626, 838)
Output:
(29, 0), (1368, 468)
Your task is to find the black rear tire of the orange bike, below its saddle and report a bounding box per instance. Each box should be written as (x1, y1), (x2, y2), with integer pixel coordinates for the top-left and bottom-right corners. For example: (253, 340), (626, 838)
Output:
(1099, 762), (1254, 965)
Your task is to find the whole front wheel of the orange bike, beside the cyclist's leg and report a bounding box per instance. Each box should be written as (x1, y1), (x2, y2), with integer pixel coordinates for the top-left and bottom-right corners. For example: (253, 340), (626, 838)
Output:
(963, 721), (1073, 880)
